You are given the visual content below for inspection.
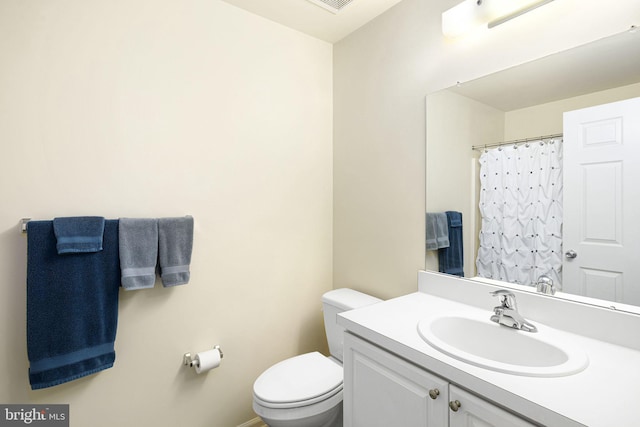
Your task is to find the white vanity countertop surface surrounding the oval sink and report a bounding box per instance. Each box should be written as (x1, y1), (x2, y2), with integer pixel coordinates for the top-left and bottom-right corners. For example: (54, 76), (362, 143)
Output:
(338, 292), (640, 427)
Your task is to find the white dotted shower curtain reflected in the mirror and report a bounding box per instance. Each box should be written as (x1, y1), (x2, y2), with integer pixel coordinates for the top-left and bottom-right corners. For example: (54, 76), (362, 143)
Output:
(476, 138), (562, 285)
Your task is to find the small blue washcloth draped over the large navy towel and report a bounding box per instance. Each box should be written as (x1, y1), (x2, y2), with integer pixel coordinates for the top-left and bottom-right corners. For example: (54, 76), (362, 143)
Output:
(53, 216), (104, 254)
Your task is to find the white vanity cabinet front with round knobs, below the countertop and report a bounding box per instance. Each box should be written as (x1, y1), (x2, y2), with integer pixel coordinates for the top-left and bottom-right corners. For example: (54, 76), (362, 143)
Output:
(343, 333), (534, 427)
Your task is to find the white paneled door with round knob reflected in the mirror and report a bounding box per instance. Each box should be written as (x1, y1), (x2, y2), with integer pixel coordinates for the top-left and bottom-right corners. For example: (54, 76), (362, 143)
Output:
(562, 98), (640, 305)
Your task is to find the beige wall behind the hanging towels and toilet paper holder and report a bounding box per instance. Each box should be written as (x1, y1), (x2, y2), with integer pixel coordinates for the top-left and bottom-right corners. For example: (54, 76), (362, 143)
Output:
(0, 0), (332, 427)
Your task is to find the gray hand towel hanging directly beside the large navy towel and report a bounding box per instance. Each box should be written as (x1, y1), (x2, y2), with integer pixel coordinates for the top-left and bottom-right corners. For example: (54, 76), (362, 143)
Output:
(119, 218), (158, 291)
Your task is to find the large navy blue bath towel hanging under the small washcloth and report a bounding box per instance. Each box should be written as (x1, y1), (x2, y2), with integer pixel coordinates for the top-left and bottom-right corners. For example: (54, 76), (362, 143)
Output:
(27, 220), (120, 390)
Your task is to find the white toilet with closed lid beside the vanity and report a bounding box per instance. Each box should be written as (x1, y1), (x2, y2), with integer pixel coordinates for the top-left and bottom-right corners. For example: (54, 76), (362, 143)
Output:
(253, 289), (381, 427)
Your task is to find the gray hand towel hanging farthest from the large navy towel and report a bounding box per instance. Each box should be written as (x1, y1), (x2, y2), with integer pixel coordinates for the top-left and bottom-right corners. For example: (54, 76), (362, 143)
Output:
(158, 216), (193, 287)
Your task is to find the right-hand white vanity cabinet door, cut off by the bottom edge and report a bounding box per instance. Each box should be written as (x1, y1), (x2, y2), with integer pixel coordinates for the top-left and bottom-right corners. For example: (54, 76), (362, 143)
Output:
(449, 385), (534, 427)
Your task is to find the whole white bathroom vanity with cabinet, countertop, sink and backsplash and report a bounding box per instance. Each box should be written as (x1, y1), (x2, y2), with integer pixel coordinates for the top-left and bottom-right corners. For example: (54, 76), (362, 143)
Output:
(338, 272), (640, 427)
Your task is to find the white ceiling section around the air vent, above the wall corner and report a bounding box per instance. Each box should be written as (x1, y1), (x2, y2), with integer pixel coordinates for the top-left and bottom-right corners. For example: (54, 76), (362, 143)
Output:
(218, 0), (401, 43)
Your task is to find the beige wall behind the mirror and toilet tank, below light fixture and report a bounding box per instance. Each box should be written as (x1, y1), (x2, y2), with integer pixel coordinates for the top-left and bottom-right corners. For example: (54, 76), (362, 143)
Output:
(333, 0), (640, 297)
